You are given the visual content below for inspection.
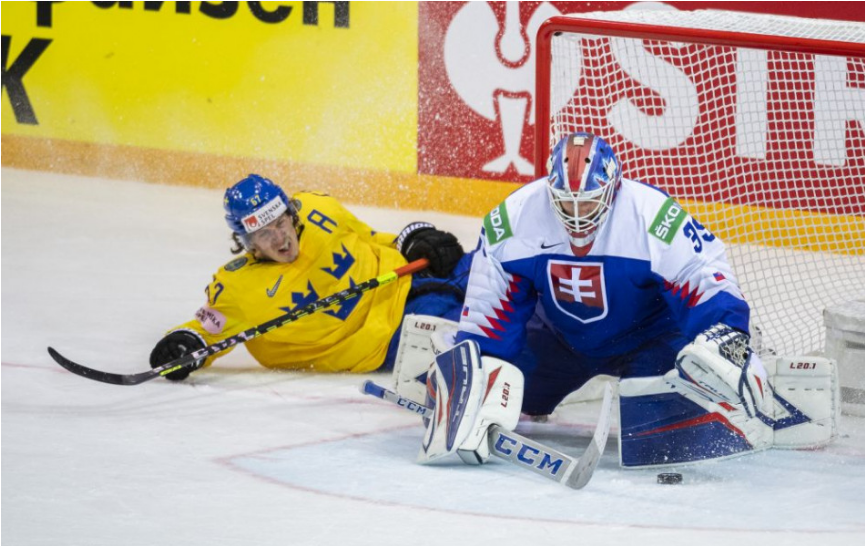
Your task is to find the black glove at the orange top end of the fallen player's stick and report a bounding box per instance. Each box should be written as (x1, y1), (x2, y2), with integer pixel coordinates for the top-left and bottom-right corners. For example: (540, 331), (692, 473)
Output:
(396, 222), (465, 278)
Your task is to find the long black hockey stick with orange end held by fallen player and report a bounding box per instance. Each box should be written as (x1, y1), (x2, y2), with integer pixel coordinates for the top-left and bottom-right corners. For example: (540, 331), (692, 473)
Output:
(48, 258), (429, 385)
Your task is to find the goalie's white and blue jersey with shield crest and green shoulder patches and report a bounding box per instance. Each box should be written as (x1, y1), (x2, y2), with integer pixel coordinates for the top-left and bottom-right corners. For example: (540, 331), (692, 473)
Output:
(457, 179), (749, 360)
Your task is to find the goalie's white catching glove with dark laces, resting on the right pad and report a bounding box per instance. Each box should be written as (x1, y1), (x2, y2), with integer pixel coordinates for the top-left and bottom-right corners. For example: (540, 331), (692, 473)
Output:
(667, 323), (771, 417)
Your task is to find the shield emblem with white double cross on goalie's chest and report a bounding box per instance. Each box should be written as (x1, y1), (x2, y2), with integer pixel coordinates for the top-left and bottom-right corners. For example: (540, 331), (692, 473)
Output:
(547, 260), (607, 323)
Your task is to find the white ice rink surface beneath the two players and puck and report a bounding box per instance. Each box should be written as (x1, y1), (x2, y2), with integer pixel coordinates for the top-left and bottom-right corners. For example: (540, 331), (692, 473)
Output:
(2, 169), (865, 546)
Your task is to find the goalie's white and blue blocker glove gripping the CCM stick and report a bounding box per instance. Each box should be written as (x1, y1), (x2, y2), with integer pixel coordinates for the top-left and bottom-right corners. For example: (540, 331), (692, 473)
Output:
(417, 340), (523, 464)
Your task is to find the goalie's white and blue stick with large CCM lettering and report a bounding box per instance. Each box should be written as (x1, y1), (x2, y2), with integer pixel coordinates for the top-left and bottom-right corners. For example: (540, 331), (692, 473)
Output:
(361, 381), (613, 489)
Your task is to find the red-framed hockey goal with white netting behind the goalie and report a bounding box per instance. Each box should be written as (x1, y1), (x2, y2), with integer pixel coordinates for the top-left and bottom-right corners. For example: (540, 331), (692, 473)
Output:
(535, 10), (865, 355)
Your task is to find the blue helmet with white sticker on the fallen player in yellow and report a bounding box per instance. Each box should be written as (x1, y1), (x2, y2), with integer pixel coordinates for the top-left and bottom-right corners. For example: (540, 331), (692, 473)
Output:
(223, 174), (297, 249)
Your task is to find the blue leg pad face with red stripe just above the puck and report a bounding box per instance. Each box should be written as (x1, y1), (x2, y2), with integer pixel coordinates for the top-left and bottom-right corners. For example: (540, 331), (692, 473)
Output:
(619, 376), (772, 468)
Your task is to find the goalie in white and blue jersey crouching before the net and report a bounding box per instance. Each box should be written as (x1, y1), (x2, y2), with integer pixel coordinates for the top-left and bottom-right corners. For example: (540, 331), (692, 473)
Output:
(404, 133), (836, 466)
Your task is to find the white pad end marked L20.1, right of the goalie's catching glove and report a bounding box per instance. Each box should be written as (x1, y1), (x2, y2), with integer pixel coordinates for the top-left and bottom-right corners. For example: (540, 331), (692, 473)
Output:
(769, 356), (841, 449)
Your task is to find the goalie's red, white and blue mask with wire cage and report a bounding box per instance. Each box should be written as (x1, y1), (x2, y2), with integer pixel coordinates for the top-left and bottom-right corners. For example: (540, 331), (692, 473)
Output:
(547, 133), (622, 247)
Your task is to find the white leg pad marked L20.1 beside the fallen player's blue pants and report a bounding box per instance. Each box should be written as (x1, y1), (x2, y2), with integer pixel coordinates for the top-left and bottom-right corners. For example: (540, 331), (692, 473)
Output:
(393, 314), (458, 405)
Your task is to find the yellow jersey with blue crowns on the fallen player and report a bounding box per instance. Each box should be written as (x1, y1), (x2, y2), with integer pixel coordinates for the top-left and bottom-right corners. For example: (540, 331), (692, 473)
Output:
(171, 192), (411, 373)
